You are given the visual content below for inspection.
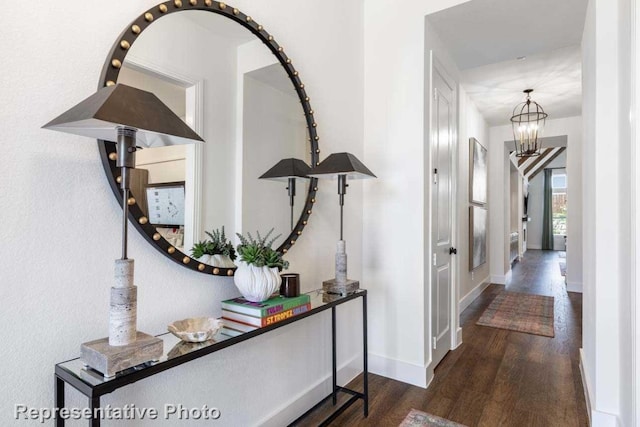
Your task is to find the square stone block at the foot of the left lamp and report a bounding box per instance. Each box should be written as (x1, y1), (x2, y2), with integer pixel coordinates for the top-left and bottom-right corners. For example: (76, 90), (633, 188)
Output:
(80, 332), (163, 378)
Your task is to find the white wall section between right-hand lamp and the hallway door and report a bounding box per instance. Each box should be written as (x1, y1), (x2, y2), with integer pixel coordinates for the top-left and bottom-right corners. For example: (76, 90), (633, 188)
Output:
(363, 0), (470, 386)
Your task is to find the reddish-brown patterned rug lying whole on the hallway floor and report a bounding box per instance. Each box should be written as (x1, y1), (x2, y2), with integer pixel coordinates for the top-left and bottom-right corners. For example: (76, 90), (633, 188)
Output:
(476, 292), (554, 337)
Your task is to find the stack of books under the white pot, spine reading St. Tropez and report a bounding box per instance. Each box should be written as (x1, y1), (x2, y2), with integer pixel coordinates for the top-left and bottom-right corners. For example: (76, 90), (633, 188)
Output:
(222, 295), (311, 337)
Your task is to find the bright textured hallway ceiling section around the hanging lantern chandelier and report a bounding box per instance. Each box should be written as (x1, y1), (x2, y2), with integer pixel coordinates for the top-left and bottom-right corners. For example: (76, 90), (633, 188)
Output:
(460, 46), (582, 126)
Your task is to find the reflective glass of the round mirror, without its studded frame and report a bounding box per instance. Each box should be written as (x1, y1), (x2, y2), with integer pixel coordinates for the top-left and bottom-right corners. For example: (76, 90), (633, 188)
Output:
(118, 10), (311, 267)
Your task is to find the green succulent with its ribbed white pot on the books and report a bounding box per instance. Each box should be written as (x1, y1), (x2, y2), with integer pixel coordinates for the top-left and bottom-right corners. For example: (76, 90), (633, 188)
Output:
(233, 228), (289, 302)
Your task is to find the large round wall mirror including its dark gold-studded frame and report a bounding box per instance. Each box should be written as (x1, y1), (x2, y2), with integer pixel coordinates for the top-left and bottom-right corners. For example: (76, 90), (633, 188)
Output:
(98, 0), (320, 276)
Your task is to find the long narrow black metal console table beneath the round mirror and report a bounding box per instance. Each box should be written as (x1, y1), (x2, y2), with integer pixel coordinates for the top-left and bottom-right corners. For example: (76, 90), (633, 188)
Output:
(55, 289), (369, 427)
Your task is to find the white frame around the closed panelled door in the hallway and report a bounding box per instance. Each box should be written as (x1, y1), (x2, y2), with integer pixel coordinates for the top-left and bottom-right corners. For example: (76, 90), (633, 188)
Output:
(424, 49), (462, 386)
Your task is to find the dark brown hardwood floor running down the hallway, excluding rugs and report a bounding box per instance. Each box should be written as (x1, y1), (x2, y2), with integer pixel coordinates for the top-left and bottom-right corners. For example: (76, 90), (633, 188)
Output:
(304, 250), (588, 427)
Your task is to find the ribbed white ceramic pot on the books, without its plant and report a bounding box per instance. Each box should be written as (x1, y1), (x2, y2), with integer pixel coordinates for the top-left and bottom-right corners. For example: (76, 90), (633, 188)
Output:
(233, 261), (282, 302)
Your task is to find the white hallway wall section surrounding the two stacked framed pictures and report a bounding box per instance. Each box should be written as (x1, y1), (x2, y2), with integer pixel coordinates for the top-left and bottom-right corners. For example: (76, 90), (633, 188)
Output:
(457, 87), (493, 312)
